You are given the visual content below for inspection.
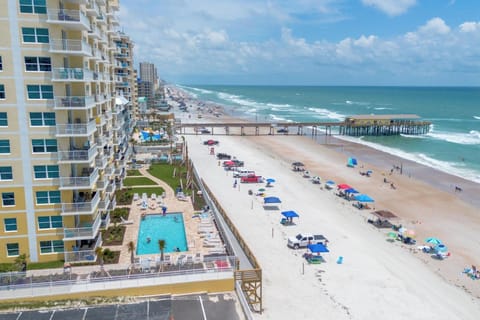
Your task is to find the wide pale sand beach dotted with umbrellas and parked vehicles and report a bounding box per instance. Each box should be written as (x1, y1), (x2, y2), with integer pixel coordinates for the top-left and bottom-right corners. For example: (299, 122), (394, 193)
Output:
(164, 85), (480, 319)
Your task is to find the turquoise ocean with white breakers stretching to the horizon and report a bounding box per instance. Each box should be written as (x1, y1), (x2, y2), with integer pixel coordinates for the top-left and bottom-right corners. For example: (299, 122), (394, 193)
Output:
(178, 85), (480, 183)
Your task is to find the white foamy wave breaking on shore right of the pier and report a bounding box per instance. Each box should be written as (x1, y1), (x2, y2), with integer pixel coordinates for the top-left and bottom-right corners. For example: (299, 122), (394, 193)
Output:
(336, 136), (480, 183)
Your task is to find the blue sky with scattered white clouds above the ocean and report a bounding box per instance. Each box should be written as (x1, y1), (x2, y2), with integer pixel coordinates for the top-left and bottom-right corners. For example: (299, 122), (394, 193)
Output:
(117, 0), (480, 86)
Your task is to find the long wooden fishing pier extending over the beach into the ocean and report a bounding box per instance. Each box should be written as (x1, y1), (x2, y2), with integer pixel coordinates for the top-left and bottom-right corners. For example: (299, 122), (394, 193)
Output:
(175, 114), (431, 136)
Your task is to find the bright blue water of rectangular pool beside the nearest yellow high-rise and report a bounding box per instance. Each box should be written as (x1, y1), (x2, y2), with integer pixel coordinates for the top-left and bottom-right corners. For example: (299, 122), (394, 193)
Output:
(137, 213), (188, 255)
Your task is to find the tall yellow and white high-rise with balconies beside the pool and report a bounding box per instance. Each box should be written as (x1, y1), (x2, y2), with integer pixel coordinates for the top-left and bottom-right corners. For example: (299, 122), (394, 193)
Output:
(0, 0), (136, 262)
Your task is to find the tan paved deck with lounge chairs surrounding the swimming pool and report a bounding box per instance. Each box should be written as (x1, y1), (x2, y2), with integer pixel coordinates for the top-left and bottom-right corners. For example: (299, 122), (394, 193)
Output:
(113, 167), (224, 264)
